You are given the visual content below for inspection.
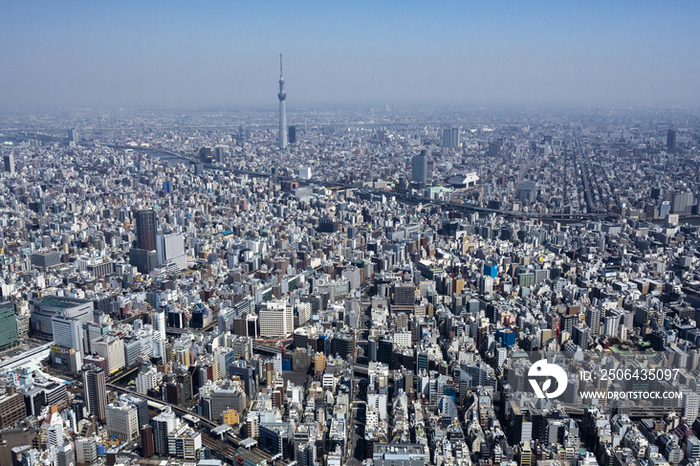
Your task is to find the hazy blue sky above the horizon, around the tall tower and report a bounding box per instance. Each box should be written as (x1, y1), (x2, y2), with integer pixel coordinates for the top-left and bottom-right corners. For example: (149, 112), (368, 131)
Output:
(0, 0), (700, 109)
